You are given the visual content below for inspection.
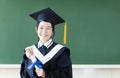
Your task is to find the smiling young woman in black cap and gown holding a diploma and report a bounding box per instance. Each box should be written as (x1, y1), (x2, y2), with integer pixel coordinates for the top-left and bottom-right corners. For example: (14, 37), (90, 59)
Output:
(20, 8), (72, 78)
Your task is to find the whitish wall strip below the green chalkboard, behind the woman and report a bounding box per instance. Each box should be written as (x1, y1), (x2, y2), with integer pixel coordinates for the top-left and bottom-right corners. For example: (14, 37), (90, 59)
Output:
(0, 65), (120, 78)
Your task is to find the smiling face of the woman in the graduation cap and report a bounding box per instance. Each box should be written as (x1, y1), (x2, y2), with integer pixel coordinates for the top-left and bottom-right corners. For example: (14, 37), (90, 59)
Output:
(36, 21), (53, 43)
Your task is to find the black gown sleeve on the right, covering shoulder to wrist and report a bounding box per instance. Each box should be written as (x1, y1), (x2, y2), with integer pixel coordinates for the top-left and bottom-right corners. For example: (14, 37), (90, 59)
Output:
(45, 48), (72, 78)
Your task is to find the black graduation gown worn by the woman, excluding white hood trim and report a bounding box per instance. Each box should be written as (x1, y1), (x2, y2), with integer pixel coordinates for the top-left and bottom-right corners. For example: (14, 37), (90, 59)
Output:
(20, 43), (72, 78)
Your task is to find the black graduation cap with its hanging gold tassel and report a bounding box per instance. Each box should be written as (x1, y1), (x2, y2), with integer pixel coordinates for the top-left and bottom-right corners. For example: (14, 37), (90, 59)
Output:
(30, 8), (67, 44)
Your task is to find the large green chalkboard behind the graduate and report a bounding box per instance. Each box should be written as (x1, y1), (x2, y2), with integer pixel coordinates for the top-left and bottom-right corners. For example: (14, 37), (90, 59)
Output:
(0, 0), (120, 64)
